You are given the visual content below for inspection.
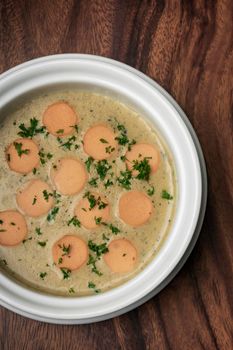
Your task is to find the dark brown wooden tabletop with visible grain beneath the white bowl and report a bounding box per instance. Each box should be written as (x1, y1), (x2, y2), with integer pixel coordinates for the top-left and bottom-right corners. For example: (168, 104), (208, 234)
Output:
(0, 0), (233, 350)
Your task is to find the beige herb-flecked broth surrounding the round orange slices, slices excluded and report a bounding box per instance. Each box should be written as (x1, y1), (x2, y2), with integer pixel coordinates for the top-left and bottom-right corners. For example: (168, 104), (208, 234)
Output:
(0, 89), (177, 296)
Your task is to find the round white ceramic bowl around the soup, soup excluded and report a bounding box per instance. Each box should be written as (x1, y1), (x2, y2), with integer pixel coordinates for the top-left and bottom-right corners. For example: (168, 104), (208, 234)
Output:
(0, 54), (205, 323)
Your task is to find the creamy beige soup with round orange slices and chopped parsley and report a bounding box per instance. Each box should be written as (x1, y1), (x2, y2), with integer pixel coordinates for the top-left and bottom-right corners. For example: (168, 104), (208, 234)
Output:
(0, 89), (177, 296)
